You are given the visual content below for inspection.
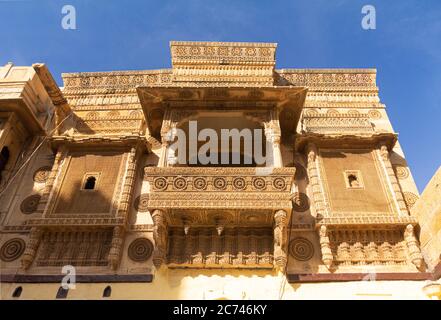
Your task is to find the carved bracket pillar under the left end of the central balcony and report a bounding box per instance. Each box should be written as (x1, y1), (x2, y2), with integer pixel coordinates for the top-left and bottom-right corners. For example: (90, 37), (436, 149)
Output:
(152, 210), (168, 269)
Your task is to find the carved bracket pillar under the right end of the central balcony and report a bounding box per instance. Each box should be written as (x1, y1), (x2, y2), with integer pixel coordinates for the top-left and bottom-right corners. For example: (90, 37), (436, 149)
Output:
(274, 210), (288, 272)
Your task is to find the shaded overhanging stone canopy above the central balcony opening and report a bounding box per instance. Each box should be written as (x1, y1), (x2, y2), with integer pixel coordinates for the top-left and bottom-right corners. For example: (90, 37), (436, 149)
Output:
(137, 86), (307, 139)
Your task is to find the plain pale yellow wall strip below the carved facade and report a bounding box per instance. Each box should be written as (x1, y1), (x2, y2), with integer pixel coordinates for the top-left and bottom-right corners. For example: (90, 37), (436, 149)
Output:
(1, 269), (434, 300)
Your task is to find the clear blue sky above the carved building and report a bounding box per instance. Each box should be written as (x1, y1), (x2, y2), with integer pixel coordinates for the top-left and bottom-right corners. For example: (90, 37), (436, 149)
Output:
(0, 0), (441, 191)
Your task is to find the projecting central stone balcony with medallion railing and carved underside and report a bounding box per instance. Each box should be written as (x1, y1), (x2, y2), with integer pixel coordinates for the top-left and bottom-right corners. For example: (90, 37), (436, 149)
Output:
(144, 167), (295, 269)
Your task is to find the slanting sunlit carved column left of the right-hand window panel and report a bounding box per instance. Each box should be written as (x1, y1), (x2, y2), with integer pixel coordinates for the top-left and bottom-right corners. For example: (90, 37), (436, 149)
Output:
(306, 143), (327, 217)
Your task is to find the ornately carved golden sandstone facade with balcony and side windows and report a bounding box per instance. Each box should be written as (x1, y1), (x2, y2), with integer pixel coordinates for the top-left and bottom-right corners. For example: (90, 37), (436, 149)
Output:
(0, 42), (439, 300)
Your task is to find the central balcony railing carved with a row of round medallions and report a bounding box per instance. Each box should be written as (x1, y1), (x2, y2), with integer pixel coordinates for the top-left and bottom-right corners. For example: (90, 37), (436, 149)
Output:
(144, 167), (295, 218)
